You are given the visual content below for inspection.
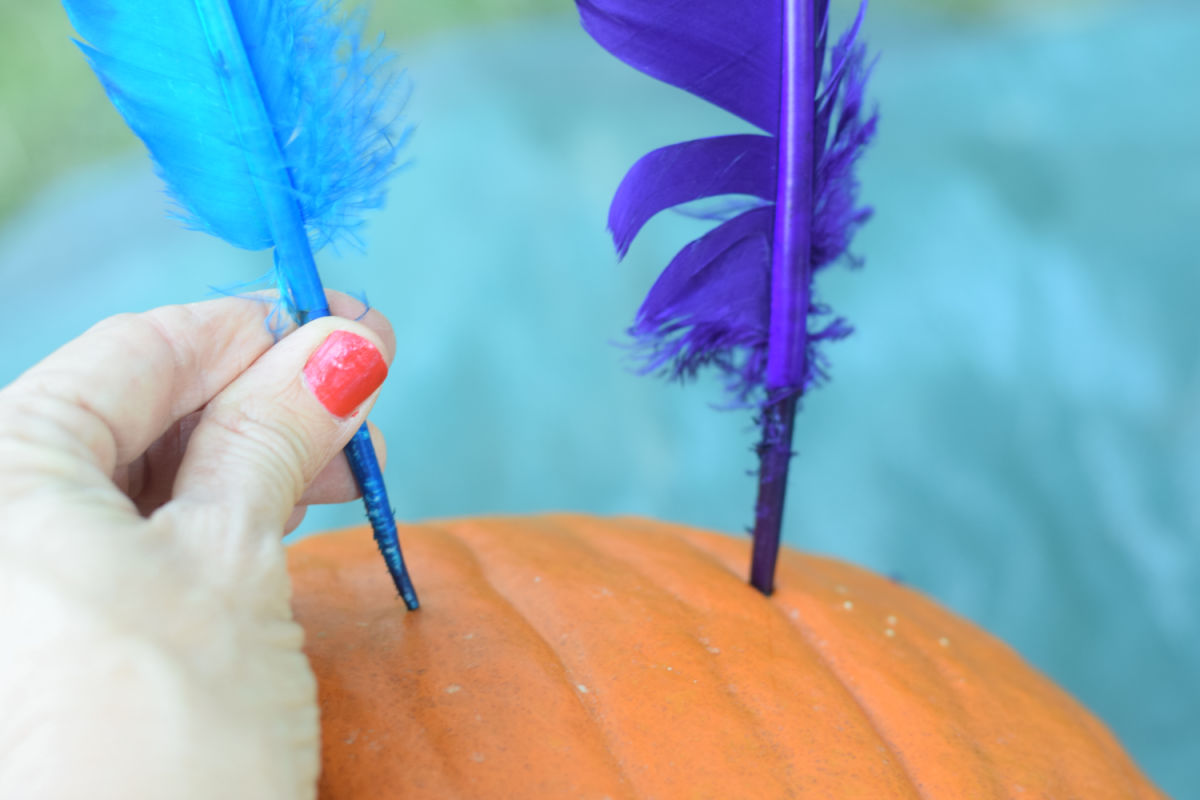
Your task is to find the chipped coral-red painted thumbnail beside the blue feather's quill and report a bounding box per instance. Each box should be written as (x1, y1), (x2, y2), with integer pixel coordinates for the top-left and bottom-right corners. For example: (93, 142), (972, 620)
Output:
(304, 331), (388, 416)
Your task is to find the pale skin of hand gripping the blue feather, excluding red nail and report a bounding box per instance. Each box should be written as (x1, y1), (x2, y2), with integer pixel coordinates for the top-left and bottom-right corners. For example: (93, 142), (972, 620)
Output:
(0, 293), (395, 800)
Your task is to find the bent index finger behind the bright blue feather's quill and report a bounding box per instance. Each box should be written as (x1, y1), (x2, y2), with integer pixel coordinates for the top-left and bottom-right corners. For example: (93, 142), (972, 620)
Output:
(0, 291), (394, 475)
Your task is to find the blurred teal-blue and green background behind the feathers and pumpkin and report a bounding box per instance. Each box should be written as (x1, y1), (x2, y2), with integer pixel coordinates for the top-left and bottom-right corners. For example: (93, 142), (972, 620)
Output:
(0, 0), (1200, 800)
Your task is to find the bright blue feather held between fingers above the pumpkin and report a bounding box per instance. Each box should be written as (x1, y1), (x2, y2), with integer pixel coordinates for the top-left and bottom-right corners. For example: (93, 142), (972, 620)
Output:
(64, 0), (418, 609)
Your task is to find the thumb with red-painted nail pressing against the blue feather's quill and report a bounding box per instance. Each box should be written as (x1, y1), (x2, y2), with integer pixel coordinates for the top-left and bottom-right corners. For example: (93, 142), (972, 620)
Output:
(168, 317), (390, 531)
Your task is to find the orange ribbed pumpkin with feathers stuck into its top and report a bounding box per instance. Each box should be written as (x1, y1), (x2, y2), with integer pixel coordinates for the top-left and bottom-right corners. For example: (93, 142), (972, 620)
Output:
(288, 515), (1165, 800)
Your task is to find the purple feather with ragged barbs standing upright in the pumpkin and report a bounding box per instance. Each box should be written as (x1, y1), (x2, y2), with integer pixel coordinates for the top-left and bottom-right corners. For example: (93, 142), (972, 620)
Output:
(576, 0), (877, 594)
